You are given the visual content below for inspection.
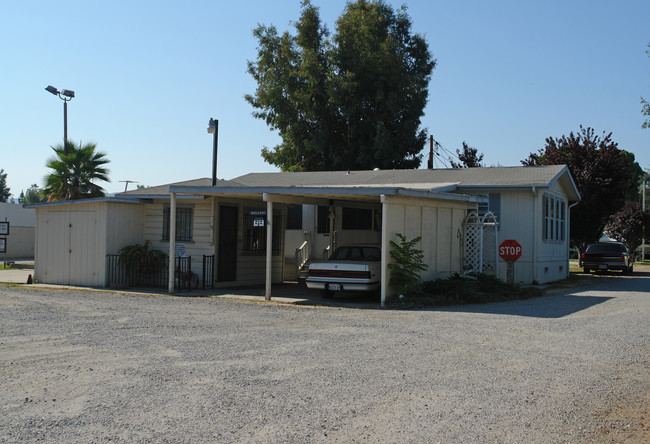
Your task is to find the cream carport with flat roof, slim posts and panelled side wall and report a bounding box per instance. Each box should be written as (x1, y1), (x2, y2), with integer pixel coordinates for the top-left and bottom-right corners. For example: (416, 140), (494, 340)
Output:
(168, 183), (486, 306)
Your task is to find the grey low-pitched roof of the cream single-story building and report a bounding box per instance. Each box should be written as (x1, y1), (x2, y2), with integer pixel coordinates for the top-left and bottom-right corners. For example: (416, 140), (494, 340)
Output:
(27, 165), (580, 209)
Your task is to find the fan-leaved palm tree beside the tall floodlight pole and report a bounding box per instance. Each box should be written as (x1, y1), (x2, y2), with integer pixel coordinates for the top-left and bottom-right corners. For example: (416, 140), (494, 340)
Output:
(43, 140), (110, 202)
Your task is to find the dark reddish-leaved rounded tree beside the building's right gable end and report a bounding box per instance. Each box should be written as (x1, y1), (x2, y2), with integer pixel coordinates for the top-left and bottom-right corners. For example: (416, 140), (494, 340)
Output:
(522, 126), (643, 251)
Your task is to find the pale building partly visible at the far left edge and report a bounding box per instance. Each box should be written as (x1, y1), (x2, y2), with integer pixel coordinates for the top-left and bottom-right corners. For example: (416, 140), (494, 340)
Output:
(0, 202), (36, 259)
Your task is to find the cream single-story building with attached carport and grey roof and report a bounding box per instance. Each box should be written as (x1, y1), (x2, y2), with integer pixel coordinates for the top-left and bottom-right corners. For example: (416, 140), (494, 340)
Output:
(33, 165), (580, 302)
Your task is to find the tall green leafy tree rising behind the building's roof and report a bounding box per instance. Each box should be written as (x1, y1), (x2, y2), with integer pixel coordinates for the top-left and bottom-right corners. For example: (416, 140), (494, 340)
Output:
(246, 0), (435, 171)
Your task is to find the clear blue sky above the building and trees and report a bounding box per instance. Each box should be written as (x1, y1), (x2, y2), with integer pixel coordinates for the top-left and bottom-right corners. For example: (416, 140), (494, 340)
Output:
(0, 0), (650, 196)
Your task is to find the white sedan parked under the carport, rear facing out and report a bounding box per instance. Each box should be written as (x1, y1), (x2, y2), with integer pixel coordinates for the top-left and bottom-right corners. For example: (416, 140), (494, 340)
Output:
(306, 244), (381, 298)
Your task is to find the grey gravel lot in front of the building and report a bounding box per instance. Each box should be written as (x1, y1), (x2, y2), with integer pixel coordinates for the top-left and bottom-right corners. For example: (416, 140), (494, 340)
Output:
(0, 272), (650, 443)
